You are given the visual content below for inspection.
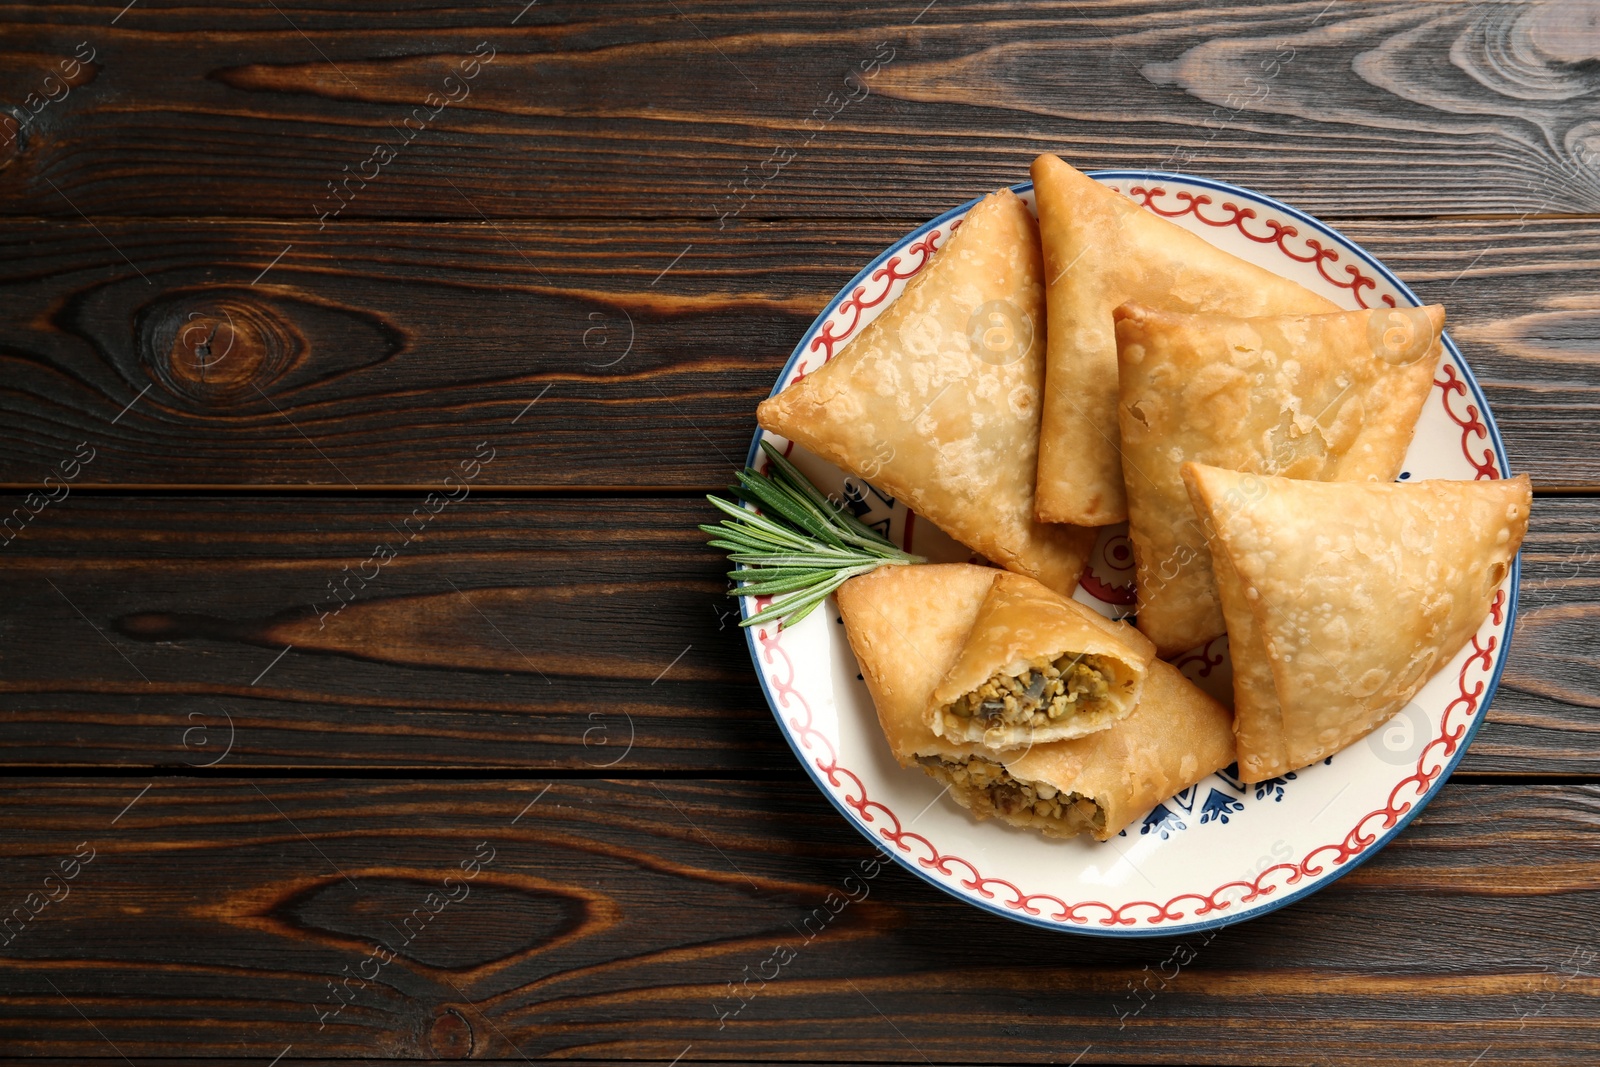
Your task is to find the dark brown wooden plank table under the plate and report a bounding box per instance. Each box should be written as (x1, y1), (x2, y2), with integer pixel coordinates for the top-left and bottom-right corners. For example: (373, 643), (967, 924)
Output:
(0, 0), (1600, 1067)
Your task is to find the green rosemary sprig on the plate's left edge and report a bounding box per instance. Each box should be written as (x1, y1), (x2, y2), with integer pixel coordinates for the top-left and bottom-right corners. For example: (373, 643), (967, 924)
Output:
(701, 442), (926, 625)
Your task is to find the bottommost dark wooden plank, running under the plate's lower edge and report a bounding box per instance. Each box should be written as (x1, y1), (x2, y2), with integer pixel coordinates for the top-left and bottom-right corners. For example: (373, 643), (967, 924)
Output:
(0, 779), (1600, 1064)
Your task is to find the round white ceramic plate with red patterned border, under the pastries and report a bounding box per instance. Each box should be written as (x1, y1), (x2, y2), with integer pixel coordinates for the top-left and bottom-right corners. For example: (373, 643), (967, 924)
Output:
(742, 171), (1520, 937)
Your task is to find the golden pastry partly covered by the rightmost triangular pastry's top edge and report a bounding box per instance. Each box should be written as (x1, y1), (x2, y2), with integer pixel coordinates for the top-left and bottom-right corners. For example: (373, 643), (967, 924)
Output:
(1115, 304), (1445, 656)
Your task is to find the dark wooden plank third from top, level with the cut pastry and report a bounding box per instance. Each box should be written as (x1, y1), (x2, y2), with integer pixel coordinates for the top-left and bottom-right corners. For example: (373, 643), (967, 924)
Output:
(0, 494), (1600, 777)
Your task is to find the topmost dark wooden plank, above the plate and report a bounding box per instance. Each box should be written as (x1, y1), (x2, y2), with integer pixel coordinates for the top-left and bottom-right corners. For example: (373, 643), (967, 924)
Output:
(0, 0), (1600, 219)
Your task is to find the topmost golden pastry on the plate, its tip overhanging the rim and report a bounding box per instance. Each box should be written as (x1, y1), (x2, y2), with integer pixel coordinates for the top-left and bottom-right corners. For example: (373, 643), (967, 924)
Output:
(1032, 155), (1339, 526)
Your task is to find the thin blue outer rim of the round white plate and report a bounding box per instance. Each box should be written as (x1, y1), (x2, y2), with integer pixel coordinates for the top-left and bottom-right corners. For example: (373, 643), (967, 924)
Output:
(739, 170), (1522, 939)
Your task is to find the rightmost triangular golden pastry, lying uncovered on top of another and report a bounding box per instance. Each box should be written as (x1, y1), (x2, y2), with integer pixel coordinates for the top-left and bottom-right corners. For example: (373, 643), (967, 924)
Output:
(1182, 462), (1531, 782)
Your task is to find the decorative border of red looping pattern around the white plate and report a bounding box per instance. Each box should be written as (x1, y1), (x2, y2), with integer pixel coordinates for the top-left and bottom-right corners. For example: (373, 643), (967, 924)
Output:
(739, 171), (1522, 937)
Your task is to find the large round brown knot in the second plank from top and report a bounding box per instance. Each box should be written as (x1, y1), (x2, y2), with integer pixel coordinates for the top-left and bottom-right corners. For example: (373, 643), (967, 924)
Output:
(139, 291), (302, 406)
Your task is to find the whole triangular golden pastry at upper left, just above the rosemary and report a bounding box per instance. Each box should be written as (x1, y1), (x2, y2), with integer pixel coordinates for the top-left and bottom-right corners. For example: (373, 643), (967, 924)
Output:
(755, 190), (1094, 593)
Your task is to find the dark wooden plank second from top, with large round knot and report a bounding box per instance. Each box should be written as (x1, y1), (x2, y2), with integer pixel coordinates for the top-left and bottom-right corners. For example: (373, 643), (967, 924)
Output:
(0, 219), (1600, 491)
